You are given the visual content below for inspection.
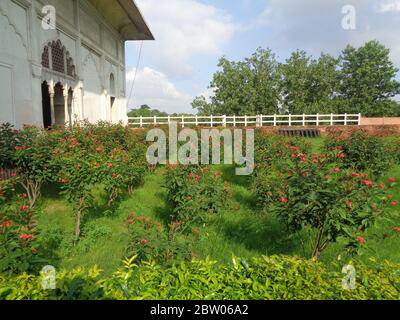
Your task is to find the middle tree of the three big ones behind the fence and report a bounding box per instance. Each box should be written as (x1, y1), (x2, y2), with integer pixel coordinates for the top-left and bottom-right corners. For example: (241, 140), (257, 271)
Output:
(280, 51), (338, 114)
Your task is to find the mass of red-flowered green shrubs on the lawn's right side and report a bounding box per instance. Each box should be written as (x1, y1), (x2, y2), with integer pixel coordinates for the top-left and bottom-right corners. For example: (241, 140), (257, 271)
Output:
(253, 132), (398, 258)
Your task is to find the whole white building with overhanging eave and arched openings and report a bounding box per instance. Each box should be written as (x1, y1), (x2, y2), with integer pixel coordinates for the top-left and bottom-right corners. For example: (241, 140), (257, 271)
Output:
(0, 0), (153, 127)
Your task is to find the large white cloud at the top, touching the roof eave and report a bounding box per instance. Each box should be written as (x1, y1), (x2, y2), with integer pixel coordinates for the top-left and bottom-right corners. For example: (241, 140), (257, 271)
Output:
(128, 0), (237, 76)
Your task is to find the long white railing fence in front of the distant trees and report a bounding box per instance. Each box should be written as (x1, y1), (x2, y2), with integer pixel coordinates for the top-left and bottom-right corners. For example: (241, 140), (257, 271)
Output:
(128, 114), (361, 128)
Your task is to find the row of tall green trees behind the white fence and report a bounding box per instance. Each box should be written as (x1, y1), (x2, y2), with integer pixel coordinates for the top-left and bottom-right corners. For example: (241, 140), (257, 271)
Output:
(192, 41), (400, 116)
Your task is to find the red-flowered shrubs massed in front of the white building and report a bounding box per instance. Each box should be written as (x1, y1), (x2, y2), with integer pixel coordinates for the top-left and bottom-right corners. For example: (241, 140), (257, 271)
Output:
(0, 122), (147, 274)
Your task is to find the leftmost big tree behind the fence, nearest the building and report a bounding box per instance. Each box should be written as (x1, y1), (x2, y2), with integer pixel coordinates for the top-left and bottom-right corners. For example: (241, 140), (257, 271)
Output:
(202, 48), (279, 115)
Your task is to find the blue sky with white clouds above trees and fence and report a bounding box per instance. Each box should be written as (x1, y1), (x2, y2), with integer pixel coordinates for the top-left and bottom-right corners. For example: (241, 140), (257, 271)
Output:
(126, 0), (400, 113)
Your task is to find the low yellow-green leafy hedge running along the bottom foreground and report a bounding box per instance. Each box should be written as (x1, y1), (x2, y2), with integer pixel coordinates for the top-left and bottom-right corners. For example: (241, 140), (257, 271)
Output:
(0, 256), (400, 300)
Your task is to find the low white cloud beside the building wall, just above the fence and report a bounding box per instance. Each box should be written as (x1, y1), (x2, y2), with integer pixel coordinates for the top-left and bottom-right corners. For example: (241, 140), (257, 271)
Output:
(126, 67), (193, 113)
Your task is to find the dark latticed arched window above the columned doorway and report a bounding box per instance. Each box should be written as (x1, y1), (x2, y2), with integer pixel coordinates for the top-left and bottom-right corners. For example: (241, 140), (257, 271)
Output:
(42, 40), (75, 78)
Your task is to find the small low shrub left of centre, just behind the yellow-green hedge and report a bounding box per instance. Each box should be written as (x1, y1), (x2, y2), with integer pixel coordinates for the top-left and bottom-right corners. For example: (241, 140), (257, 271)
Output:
(126, 213), (191, 265)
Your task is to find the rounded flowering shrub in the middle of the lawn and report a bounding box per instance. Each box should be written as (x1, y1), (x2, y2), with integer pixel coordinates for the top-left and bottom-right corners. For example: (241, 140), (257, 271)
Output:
(165, 165), (230, 229)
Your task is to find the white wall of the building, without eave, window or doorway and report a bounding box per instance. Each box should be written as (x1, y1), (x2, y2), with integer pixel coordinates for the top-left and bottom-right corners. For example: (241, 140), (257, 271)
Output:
(0, 0), (126, 127)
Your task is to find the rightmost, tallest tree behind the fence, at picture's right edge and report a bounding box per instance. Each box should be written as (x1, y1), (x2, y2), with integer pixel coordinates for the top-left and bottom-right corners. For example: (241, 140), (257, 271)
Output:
(339, 41), (400, 116)
